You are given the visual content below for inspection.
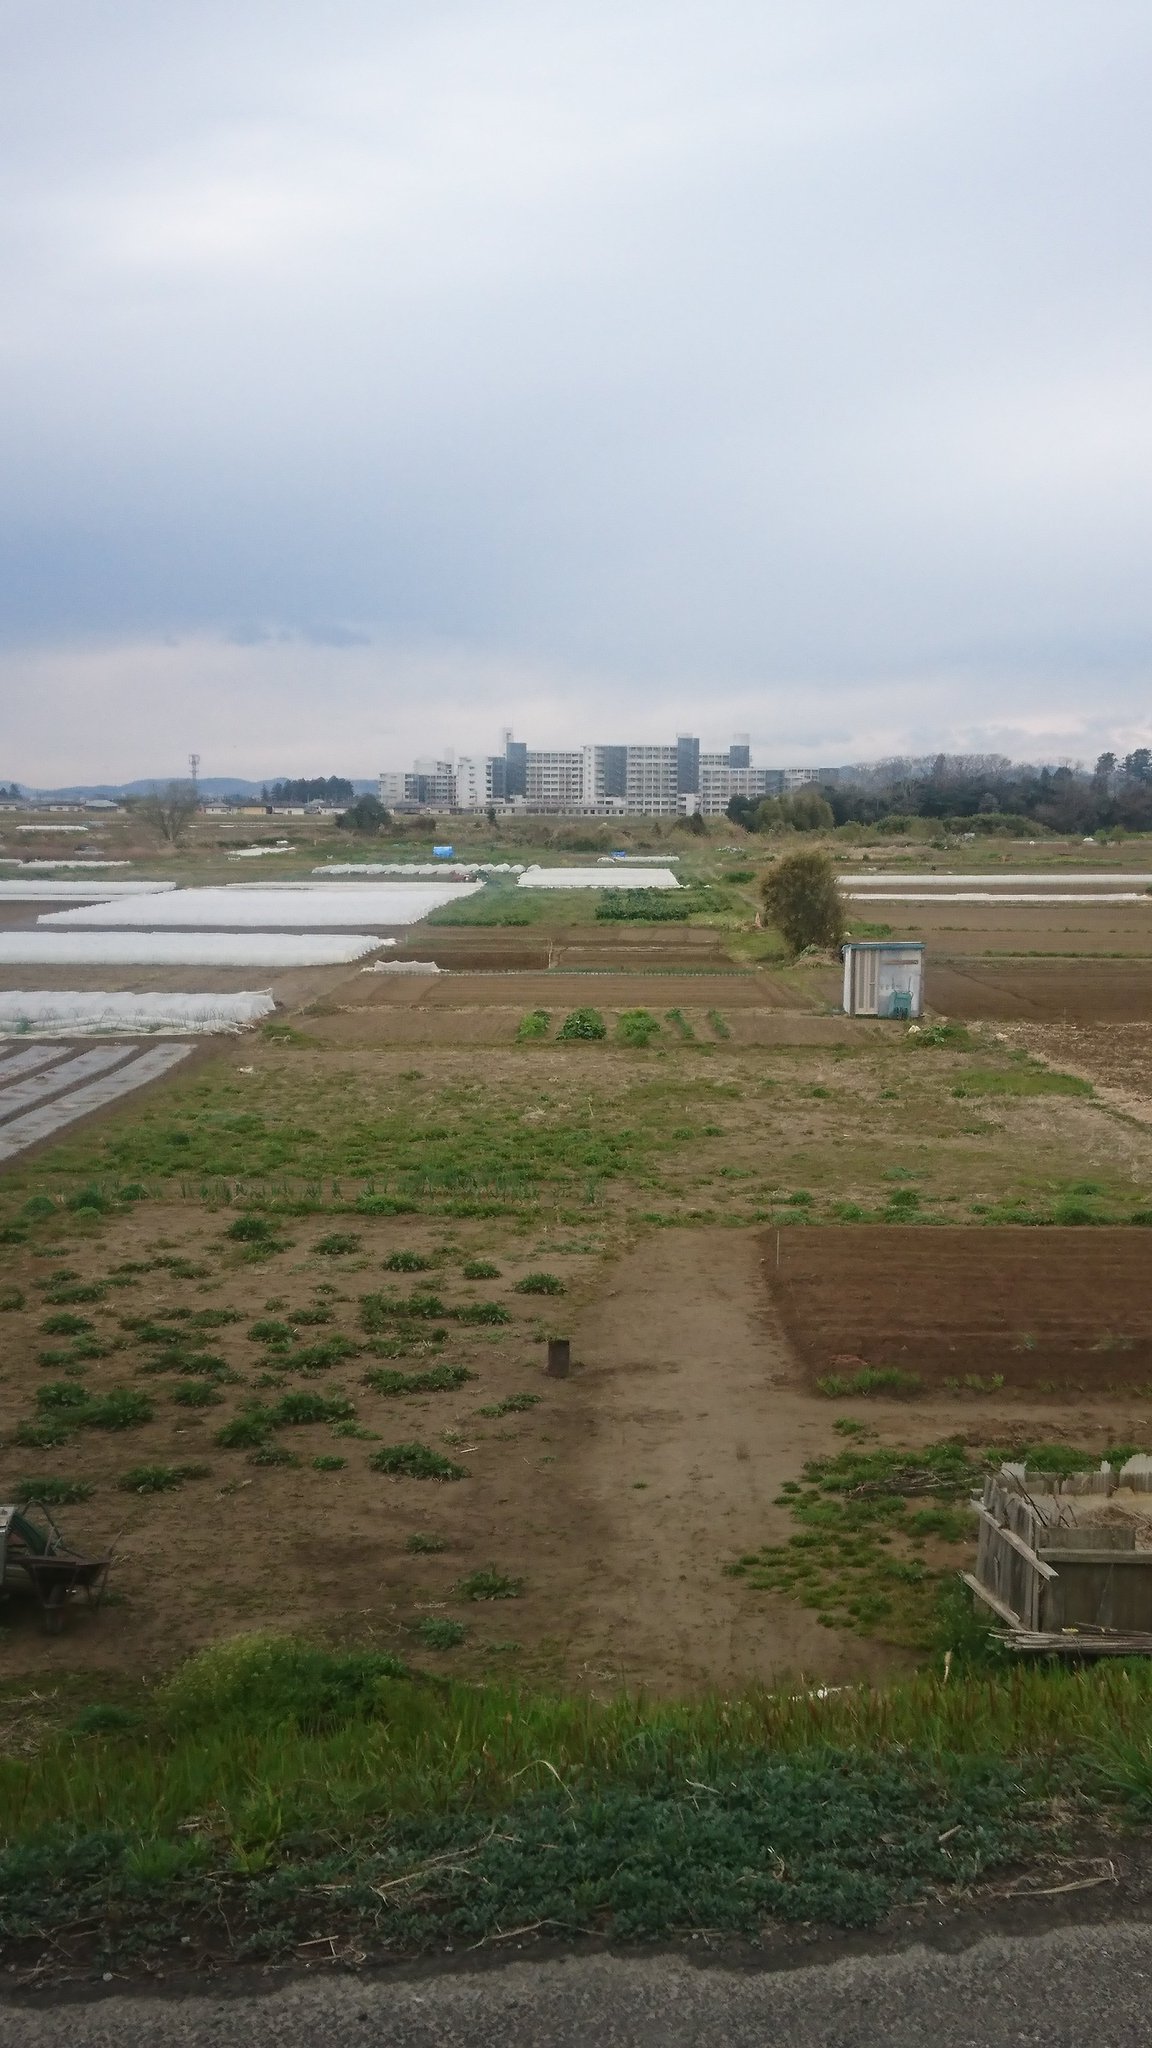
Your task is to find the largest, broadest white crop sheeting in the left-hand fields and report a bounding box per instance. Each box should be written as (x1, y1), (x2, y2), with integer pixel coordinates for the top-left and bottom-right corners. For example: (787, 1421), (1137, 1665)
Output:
(39, 883), (475, 932)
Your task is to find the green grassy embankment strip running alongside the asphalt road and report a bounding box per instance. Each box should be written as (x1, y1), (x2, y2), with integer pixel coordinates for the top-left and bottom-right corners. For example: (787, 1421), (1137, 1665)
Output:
(11, 1622), (1152, 1964)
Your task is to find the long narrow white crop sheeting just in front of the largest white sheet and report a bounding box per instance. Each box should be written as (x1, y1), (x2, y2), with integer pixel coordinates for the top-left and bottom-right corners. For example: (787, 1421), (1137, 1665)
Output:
(0, 924), (387, 967)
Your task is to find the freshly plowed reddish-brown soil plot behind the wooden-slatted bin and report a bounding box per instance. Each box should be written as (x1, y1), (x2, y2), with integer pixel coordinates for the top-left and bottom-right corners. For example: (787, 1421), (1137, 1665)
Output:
(767, 1227), (1152, 1393)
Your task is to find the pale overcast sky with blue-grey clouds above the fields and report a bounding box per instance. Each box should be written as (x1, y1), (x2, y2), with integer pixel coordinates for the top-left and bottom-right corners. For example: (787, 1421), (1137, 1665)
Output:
(0, 0), (1152, 784)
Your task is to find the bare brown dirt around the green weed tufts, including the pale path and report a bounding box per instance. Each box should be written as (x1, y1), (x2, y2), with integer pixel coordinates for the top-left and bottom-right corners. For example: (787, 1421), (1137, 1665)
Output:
(0, 1206), (1152, 1694)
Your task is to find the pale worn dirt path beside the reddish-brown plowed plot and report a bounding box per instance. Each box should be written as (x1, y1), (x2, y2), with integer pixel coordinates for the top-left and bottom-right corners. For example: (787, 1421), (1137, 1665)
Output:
(570, 1229), (898, 1692)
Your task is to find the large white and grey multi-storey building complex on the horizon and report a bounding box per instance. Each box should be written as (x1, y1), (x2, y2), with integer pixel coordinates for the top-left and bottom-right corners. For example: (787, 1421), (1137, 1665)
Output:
(379, 733), (832, 817)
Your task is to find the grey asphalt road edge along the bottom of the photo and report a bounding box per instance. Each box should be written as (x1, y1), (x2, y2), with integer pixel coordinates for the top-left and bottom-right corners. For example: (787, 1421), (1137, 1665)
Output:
(0, 1921), (1152, 2048)
